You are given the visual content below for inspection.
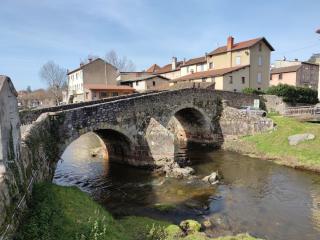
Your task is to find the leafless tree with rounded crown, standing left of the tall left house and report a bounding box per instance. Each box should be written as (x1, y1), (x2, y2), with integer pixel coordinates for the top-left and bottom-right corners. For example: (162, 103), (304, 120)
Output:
(40, 61), (67, 105)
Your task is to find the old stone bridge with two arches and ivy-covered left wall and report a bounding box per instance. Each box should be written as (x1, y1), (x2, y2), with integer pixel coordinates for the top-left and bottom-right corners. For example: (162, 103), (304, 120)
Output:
(0, 85), (272, 239)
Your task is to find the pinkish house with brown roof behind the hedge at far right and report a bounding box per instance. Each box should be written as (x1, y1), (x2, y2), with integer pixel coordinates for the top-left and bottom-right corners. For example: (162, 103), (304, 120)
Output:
(270, 60), (319, 90)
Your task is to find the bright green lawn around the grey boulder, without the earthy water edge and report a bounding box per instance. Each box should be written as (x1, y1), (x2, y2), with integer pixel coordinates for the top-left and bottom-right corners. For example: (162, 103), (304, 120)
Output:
(243, 116), (320, 170)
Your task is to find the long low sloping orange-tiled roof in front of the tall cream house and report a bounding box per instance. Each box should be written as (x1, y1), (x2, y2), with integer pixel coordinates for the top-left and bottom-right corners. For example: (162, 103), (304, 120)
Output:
(171, 65), (249, 82)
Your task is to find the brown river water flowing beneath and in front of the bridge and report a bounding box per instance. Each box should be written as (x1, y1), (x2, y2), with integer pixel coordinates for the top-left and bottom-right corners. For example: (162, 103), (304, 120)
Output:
(54, 134), (320, 240)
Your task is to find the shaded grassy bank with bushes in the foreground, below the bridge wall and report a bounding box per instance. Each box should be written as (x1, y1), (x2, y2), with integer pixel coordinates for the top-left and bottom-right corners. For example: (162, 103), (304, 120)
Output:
(13, 183), (262, 240)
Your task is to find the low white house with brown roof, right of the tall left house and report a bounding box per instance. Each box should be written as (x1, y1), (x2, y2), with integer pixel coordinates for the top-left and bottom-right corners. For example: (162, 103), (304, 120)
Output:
(121, 75), (170, 92)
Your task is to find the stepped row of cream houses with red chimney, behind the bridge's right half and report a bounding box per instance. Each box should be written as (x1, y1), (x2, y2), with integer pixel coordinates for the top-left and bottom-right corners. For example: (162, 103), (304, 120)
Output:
(148, 36), (274, 91)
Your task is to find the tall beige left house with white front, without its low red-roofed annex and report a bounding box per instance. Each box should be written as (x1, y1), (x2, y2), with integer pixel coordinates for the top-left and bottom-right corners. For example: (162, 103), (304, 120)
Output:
(65, 58), (118, 103)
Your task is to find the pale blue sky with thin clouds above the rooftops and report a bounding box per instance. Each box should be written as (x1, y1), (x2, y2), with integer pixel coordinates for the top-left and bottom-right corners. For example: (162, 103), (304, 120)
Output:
(0, 0), (320, 89)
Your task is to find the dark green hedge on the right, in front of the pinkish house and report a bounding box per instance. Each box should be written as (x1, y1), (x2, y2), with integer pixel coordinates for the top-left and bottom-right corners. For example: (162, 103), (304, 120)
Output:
(266, 84), (318, 104)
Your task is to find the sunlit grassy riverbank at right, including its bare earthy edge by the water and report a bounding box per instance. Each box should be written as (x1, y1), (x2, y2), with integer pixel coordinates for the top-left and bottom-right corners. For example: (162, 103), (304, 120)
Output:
(223, 116), (320, 173)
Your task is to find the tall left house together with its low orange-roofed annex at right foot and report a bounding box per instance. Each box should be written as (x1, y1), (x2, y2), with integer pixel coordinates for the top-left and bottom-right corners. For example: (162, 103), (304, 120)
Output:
(67, 58), (129, 103)
